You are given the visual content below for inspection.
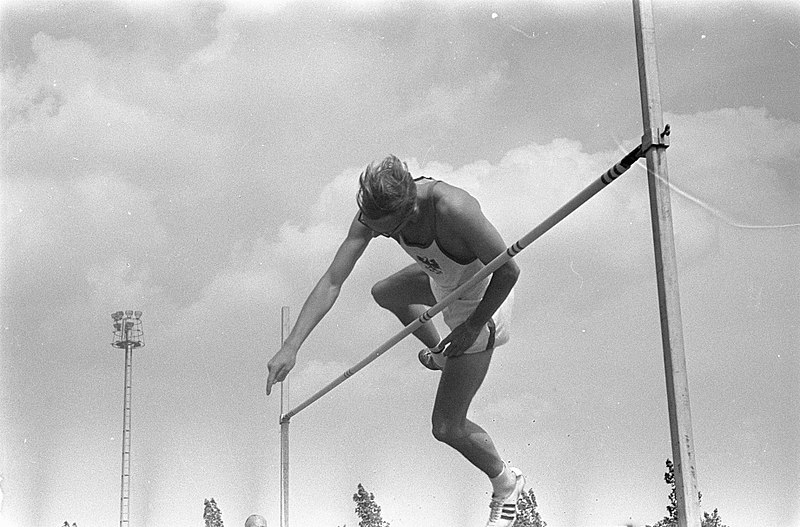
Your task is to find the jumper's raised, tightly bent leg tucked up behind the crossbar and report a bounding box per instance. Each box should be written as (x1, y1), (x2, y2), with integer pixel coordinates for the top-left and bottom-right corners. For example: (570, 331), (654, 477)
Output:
(372, 264), (440, 347)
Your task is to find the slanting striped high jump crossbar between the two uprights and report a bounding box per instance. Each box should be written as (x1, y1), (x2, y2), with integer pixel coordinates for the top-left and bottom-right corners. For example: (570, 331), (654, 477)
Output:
(280, 141), (644, 425)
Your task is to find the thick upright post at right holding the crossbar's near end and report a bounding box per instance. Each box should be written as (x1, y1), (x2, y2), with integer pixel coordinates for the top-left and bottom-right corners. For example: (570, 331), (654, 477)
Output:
(633, 0), (701, 527)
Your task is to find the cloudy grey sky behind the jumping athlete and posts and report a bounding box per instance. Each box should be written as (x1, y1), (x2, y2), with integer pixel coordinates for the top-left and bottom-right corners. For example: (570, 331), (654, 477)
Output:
(0, 0), (800, 527)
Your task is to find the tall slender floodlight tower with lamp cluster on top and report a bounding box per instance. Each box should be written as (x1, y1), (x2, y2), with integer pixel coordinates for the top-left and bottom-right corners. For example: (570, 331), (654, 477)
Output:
(111, 311), (144, 527)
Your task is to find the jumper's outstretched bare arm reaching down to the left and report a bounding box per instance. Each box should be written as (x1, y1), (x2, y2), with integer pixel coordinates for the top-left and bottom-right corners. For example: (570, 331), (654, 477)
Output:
(267, 219), (372, 395)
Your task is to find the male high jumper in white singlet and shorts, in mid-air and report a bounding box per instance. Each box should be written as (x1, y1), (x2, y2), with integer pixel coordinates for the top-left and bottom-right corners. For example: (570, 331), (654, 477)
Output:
(267, 156), (525, 527)
